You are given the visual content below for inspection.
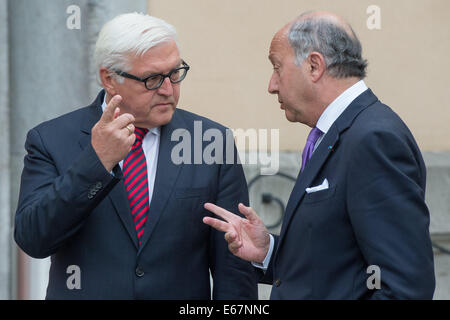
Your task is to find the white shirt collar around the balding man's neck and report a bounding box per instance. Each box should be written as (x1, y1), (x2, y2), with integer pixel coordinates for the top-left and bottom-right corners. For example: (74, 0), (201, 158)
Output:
(316, 80), (368, 136)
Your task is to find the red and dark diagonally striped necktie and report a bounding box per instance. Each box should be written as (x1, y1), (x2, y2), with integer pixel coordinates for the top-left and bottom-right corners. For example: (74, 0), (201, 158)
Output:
(122, 128), (150, 245)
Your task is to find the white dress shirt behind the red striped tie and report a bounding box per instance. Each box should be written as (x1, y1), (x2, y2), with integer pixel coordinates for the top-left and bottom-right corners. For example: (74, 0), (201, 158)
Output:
(102, 94), (161, 203)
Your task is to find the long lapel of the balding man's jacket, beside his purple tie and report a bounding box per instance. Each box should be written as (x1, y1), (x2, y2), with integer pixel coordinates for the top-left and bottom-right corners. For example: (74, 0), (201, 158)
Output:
(278, 89), (378, 256)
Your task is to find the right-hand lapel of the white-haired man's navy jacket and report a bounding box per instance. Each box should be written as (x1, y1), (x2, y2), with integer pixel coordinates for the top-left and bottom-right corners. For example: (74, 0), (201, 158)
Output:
(138, 111), (185, 255)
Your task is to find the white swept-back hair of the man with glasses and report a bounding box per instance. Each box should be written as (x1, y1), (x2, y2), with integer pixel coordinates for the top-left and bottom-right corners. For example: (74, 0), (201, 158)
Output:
(94, 12), (178, 82)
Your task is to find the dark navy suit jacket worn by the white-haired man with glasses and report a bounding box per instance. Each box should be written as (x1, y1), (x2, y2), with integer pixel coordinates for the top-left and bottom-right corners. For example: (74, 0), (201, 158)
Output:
(14, 91), (257, 299)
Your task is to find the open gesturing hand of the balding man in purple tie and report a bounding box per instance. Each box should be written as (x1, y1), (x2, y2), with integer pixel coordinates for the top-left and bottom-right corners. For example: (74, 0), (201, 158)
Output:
(203, 203), (270, 263)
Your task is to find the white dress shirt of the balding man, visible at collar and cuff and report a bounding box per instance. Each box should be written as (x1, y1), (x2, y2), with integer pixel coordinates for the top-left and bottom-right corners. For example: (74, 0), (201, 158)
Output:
(252, 80), (368, 271)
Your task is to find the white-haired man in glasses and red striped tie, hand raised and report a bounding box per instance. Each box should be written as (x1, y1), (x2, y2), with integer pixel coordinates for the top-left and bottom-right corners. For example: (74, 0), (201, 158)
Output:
(14, 13), (257, 299)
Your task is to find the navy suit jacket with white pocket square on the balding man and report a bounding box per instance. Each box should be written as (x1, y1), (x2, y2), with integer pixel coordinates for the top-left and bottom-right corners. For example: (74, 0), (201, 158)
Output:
(263, 89), (435, 299)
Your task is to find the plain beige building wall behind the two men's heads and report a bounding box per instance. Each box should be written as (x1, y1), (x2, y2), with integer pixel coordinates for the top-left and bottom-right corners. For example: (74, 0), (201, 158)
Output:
(148, 0), (450, 151)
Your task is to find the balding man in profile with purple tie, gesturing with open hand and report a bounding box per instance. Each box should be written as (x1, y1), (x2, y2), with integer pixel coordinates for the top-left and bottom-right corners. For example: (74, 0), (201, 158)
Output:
(203, 12), (435, 299)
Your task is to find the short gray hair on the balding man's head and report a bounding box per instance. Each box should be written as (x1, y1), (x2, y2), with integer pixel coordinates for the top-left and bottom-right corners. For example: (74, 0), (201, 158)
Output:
(289, 14), (367, 79)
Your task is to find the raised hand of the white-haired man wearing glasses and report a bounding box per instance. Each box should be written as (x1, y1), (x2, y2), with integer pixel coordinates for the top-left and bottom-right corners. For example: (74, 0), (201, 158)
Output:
(91, 95), (136, 172)
